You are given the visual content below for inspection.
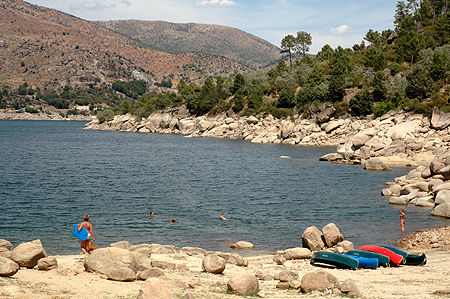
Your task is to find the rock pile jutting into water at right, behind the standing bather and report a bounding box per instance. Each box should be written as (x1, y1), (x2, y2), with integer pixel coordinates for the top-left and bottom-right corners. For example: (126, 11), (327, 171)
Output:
(381, 151), (450, 218)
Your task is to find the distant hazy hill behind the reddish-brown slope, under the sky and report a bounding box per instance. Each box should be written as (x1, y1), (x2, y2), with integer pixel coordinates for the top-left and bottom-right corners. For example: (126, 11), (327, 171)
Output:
(95, 20), (281, 69)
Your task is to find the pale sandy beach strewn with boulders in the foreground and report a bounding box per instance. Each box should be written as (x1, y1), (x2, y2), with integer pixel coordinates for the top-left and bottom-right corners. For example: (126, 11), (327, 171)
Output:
(0, 228), (450, 299)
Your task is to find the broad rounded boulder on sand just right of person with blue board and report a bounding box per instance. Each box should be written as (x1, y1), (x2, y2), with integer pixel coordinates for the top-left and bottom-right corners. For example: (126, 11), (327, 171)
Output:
(84, 247), (138, 281)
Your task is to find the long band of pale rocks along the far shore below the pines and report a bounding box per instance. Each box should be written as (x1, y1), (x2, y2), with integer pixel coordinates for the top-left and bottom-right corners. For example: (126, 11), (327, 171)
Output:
(86, 105), (450, 170)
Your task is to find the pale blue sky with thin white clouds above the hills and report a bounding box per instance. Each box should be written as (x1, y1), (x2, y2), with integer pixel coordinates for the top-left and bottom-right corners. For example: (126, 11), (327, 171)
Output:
(27, 0), (397, 53)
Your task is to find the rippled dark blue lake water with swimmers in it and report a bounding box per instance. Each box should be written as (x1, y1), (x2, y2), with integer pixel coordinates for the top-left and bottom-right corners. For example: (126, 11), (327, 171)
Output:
(0, 121), (448, 254)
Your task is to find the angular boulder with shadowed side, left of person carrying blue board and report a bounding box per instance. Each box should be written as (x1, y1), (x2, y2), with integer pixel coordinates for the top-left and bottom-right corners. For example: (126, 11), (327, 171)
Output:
(11, 240), (47, 268)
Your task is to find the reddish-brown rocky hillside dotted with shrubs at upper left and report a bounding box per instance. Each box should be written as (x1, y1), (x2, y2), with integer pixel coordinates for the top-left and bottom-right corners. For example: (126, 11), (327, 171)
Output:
(0, 0), (248, 87)
